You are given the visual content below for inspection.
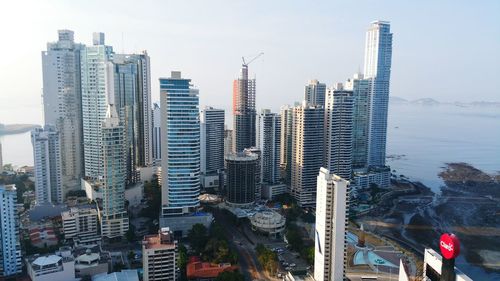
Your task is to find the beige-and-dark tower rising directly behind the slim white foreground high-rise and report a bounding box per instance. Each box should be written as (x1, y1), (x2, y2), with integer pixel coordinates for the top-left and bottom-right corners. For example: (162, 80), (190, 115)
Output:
(290, 102), (325, 207)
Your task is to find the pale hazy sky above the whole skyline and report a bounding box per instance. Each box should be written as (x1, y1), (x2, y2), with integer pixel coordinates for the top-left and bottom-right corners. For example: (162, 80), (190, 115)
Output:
(0, 0), (500, 123)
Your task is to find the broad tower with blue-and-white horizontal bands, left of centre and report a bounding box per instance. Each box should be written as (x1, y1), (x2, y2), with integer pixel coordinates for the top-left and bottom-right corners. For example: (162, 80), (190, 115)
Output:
(160, 71), (200, 216)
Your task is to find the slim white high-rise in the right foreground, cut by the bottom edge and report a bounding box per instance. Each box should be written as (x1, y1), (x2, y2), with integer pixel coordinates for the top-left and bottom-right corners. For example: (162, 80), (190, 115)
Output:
(314, 168), (349, 281)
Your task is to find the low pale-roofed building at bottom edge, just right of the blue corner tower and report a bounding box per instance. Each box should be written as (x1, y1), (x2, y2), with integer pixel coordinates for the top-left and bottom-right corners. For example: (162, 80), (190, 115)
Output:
(26, 254), (78, 281)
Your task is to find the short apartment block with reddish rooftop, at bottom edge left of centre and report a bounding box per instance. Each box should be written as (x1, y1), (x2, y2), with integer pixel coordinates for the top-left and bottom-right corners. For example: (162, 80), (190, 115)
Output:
(142, 228), (178, 281)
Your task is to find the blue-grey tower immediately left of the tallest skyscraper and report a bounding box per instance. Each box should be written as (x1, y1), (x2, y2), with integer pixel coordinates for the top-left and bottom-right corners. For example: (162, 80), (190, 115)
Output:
(344, 74), (370, 170)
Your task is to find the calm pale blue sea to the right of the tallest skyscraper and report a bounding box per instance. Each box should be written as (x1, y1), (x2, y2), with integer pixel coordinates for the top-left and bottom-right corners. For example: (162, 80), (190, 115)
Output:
(387, 104), (500, 192)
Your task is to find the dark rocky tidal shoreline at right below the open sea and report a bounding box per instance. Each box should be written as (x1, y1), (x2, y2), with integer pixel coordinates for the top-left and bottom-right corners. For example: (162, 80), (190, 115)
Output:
(358, 163), (500, 280)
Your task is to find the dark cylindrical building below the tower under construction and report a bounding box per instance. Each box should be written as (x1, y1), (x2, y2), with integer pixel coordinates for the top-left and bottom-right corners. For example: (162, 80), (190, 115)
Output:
(226, 152), (259, 207)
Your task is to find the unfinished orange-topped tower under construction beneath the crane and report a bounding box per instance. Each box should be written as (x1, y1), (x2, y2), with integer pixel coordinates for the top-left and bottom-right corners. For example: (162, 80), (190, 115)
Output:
(233, 64), (256, 152)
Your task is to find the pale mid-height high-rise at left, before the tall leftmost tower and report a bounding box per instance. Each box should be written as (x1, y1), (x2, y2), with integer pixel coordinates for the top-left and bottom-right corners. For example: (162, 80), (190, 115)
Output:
(31, 125), (64, 205)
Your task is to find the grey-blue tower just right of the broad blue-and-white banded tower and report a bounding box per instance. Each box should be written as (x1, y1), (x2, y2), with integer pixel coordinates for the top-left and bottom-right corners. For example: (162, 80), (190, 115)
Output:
(200, 107), (225, 187)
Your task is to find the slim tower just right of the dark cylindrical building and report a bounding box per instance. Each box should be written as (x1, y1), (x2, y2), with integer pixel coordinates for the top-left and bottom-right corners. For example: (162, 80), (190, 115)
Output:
(257, 109), (281, 184)
